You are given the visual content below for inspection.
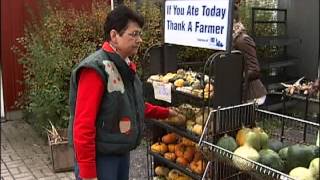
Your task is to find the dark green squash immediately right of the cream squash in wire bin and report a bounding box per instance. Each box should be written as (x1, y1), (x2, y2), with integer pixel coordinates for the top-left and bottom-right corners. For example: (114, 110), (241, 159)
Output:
(259, 149), (284, 171)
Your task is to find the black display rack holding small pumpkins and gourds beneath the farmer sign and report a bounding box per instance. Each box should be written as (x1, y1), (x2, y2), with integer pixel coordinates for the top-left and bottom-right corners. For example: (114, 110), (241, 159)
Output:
(144, 51), (244, 180)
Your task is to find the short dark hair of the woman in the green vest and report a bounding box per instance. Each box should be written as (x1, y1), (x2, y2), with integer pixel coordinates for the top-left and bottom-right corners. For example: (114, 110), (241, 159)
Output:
(104, 5), (144, 41)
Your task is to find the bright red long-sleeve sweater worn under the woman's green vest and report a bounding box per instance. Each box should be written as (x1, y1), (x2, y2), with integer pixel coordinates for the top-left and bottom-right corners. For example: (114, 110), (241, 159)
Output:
(73, 43), (169, 178)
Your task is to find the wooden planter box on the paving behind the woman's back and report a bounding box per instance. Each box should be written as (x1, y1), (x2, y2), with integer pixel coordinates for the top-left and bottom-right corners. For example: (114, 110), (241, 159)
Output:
(48, 130), (74, 172)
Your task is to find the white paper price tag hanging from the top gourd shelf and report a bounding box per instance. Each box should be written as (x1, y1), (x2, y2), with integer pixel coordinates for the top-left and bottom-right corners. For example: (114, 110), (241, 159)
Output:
(152, 82), (171, 103)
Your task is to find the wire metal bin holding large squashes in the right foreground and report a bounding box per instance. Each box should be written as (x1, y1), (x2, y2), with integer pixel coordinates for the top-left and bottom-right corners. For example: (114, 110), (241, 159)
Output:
(199, 103), (320, 179)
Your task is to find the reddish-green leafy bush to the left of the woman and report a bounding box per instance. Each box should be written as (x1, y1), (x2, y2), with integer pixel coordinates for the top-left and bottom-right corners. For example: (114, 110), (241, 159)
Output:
(13, 2), (109, 134)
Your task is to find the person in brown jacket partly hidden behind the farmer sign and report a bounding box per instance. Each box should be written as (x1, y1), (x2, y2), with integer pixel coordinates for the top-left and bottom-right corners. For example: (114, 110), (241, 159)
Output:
(232, 0), (267, 105)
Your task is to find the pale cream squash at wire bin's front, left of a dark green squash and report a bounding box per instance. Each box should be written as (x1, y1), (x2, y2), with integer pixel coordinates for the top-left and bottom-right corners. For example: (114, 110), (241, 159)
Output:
(232, 145), (260, 171)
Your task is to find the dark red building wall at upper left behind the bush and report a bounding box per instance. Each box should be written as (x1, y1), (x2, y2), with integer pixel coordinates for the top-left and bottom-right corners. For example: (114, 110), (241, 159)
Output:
(0, 0), (97, 113)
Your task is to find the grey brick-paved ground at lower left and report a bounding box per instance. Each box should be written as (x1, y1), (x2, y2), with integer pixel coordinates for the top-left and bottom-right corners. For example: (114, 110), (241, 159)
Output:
(1, 120), (75, 180)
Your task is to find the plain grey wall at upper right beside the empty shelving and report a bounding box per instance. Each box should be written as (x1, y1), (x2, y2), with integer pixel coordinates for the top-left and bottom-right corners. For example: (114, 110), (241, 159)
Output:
(279, 0), (319, 79)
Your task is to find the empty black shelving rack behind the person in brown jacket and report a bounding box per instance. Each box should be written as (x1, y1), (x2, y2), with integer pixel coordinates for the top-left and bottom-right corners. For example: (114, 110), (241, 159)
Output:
(251, 7), (301, 92)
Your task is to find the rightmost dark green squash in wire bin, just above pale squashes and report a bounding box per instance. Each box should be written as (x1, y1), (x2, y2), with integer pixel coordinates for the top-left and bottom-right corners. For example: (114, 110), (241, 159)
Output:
(287, 144), (314, 170)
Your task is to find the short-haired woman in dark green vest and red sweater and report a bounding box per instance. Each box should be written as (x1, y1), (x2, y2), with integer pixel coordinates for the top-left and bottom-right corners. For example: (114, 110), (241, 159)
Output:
(69, 5), (177, 180)
